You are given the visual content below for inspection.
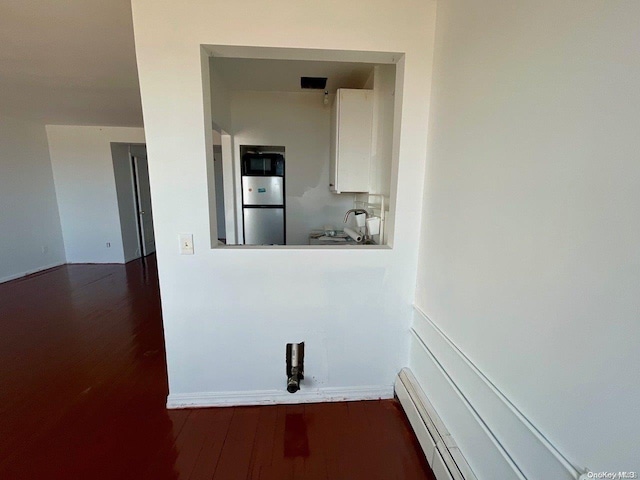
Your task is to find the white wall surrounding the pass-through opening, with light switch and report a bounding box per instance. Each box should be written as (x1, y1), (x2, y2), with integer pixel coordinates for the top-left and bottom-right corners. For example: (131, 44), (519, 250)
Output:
(132, 0), (435, 405)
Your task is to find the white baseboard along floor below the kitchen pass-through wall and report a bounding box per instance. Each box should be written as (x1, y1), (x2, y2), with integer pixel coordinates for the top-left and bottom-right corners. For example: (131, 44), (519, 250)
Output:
(167, 382), (393, 409)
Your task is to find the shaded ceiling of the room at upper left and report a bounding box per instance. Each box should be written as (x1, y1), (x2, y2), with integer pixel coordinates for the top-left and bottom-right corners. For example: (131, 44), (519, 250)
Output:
(0, 0), (142, 126)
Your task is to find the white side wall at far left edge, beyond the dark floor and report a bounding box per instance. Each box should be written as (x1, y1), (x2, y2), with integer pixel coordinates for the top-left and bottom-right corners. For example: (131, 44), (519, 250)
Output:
(0, 116), (65, 282)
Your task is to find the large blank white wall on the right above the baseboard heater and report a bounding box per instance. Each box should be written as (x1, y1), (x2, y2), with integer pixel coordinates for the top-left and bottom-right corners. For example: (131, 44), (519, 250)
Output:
(412, 0), (640, 478)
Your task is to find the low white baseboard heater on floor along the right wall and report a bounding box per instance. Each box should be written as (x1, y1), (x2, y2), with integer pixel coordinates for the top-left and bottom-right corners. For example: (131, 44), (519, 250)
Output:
(395, 368), (477, 480)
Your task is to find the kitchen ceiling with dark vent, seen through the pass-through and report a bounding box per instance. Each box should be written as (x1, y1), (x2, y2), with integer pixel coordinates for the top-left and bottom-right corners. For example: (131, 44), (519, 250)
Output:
(213, 57), (374, 93)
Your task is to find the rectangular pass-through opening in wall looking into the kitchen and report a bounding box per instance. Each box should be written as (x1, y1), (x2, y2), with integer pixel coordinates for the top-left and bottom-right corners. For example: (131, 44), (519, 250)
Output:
(203, 47), (402, 248)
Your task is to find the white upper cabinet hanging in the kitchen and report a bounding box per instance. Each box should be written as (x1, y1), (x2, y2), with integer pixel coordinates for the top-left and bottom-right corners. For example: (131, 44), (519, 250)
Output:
(329, 88), (373, 193)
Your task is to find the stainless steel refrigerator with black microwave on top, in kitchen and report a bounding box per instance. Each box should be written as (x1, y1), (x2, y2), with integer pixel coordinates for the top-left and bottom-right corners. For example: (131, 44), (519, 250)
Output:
(242, 154), (286, 245)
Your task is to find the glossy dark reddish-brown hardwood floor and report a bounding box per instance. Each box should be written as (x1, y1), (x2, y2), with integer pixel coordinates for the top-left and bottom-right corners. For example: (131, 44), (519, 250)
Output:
(0, 257), (434, 480)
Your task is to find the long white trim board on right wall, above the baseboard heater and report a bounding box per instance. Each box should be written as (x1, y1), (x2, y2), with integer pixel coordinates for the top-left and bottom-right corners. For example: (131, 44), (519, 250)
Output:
(410, 308), (580, 480)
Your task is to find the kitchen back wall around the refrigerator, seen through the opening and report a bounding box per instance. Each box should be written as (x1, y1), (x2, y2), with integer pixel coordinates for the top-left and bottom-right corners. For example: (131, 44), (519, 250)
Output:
(231, 92), (353, 245)
